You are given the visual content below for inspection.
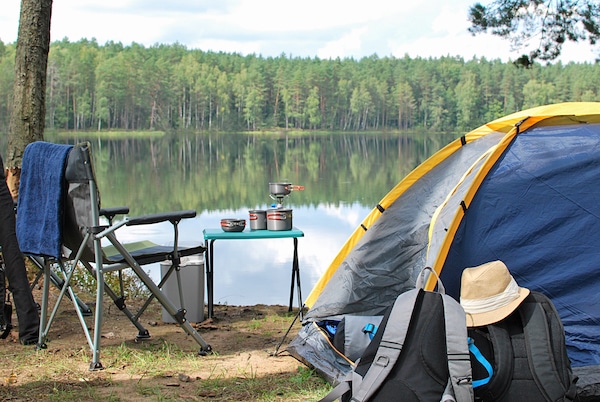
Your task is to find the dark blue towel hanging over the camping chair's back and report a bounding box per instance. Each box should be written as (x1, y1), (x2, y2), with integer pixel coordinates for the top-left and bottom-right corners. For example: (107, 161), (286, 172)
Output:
(16, 141), (73, 259)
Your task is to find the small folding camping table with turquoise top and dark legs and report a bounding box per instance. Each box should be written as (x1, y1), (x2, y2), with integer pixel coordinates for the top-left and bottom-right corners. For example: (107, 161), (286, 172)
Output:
(203, 228), (304, 319)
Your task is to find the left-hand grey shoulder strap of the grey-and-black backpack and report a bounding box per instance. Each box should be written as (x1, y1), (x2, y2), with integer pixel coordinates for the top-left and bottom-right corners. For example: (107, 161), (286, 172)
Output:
(352, 289), (424, 402)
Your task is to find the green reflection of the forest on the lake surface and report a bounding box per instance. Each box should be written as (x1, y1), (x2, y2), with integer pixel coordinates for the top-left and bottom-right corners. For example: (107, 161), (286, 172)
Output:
(69, 133), (449, 214)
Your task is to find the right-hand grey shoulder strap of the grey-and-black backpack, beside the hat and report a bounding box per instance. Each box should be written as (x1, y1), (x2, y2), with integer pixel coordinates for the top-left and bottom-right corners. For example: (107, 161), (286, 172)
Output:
(442, 294), (474, 402)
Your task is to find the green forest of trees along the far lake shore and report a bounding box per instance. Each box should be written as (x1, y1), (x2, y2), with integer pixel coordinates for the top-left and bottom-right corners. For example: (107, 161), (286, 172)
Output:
(0, 39), (600, 133)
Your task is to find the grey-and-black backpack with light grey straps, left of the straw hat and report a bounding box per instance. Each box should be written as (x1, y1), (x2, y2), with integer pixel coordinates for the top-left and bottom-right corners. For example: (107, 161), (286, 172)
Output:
(321, 268), (473, 402)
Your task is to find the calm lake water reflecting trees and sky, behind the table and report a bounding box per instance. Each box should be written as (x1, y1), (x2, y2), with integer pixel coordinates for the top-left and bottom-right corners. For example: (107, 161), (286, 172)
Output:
(59, 133), (455, 306)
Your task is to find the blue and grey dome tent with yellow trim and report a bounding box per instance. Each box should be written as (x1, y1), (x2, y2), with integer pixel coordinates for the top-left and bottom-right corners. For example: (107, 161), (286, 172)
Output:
(288, 102), (600, 394)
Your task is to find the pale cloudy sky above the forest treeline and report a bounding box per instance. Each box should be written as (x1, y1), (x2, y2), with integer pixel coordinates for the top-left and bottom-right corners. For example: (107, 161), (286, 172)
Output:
(0, 0), (596, 63)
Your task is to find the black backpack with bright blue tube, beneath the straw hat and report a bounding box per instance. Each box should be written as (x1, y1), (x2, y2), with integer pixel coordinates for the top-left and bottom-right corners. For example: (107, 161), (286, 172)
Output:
(468, 292), (577, 402)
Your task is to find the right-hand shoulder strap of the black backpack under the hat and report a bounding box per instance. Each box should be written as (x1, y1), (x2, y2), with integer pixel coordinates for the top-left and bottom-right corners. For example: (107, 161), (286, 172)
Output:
(518, 298), (576, 401)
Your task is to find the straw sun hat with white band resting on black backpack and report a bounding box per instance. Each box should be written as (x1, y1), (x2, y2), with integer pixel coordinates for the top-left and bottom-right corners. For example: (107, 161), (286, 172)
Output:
(460, 261), (529, 327)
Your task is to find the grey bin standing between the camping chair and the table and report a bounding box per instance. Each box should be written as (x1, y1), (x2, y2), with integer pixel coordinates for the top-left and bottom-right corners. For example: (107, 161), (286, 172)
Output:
(160, 255), (204, 323)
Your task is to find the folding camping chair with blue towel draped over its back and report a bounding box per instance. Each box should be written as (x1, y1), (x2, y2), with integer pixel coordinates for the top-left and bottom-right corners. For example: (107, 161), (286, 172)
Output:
(17, 141), (212, 370)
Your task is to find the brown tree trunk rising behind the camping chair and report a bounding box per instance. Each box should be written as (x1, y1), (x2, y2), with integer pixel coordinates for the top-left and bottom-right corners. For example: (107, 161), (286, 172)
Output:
(5, 0), (52, 199)
